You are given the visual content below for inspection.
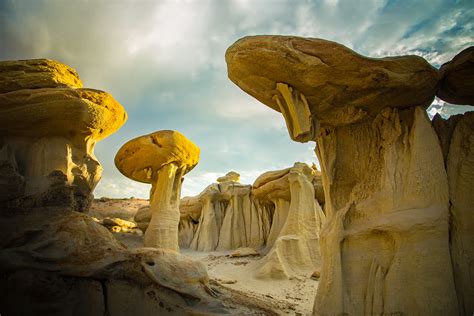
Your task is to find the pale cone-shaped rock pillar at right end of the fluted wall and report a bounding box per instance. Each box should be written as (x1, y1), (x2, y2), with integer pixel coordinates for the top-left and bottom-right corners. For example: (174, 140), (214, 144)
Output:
(253, 163), (325, 279)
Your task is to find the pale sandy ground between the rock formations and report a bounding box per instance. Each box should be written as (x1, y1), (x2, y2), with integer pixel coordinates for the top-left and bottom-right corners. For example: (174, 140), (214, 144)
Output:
(90, 199), (319, 315)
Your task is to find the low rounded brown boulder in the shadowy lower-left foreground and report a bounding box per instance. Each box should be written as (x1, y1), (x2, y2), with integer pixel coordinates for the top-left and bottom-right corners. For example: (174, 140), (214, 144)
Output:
(0, 208), (225, 315)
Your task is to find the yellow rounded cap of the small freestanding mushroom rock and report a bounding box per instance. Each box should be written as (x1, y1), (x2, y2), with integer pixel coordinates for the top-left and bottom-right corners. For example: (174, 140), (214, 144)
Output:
(115, 130), (199, 183)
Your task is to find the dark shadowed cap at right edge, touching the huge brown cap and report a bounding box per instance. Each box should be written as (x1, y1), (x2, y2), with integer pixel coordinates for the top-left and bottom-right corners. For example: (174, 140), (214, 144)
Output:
(436, 46), (474, 105)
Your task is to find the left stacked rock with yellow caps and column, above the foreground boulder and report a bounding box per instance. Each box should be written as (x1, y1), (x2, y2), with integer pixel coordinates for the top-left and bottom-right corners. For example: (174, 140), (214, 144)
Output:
(0, 59), (127, 211)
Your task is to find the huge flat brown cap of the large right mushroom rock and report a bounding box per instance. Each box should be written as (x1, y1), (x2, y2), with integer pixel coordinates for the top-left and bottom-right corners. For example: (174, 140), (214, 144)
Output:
(226, 36), (439, 125)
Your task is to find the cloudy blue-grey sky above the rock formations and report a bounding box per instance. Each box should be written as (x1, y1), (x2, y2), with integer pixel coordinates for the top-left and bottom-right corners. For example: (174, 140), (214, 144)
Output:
(0, 0), (474, 198)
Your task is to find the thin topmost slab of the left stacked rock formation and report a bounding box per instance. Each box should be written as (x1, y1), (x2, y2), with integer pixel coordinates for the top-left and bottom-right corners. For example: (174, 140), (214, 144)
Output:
(0, 59), (82, 93)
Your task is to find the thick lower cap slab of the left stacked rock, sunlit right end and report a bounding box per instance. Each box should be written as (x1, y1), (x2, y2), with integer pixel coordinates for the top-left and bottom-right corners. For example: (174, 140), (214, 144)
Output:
(0, 88), (127, 140)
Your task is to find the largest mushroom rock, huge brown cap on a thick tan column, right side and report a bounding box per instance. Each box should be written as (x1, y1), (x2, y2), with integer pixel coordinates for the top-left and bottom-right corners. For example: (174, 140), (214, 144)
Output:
(226, 36), (472, 315)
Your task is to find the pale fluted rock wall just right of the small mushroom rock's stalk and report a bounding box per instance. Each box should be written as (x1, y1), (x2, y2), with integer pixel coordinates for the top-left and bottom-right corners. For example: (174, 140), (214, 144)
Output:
(135, 172), (273, 251)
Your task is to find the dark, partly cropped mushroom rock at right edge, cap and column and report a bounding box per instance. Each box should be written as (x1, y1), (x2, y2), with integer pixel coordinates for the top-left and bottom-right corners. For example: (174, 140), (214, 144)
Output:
(433, 55), (474, 315)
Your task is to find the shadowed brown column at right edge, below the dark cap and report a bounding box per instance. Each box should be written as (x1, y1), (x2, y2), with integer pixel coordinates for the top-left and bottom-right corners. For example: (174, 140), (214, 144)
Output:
(433, 112), (474, 315)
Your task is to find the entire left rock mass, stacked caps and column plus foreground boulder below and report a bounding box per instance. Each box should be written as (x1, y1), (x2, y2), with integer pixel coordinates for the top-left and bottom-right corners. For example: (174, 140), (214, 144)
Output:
(0, 60), (227, 315)
